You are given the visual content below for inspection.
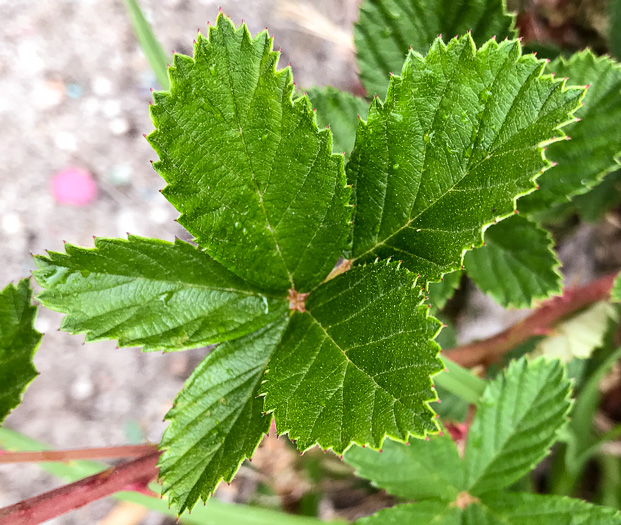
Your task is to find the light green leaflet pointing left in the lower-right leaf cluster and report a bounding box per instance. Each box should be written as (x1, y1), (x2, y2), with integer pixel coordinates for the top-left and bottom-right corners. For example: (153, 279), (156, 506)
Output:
(344, 436), (464, 503)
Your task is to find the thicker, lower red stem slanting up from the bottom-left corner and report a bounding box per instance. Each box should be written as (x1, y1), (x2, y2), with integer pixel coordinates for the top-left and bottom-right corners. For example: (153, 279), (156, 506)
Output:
(0, 450), (160, 525)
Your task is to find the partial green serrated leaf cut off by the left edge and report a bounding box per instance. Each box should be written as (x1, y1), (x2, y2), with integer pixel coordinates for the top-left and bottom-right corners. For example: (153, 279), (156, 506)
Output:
(0, 279), (41, 423)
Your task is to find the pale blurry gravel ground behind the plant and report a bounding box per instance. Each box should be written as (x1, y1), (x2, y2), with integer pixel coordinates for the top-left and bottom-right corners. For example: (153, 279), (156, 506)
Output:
(0, 0), (621, 525)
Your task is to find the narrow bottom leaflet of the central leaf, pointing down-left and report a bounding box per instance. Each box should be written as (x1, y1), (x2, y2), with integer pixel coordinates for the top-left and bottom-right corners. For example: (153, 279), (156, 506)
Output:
(159, 315), (288, 514)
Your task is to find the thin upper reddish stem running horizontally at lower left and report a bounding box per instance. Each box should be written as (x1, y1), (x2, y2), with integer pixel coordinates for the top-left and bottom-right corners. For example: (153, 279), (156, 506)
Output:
(0, 444), (157, 463)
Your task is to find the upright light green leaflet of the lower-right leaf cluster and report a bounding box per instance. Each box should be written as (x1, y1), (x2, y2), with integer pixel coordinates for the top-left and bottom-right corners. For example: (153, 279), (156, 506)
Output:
(465, 358), (571, 496)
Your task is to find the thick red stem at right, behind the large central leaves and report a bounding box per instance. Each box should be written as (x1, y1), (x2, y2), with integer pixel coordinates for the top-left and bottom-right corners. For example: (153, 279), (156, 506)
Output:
(444, 273), (617, 368)
